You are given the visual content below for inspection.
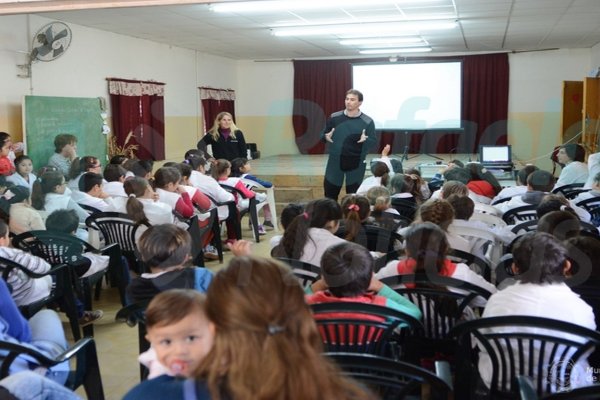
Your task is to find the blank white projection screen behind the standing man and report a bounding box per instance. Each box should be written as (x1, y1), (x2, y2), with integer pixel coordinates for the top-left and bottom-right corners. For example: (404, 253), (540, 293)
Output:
(352, 61), (462, 131)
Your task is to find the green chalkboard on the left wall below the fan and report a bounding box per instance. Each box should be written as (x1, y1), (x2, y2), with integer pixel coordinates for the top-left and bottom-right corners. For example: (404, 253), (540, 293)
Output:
(23, 96), (107, 171)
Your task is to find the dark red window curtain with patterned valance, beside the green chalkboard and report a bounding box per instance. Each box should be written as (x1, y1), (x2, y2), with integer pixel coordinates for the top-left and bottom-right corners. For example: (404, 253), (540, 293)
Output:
(108, 78), (165, 160)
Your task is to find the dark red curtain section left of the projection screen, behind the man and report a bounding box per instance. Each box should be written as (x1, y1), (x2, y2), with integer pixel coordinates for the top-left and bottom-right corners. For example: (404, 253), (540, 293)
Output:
(292, 60), (352, 154)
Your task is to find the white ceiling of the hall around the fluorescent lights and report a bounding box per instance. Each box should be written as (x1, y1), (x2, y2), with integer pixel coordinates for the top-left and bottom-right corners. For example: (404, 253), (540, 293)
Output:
(23, 0), (600, 60)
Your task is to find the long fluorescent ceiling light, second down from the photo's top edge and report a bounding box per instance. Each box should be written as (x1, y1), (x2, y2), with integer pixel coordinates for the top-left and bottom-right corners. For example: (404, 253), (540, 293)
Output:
(271, 21), (457, 37)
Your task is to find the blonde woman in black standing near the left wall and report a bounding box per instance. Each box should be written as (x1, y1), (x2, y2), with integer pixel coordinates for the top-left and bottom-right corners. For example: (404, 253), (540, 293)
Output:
(198, 111), (247, 161)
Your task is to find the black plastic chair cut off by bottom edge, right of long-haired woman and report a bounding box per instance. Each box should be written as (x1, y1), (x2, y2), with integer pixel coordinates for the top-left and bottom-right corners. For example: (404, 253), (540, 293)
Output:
(326, 353), (452, 400)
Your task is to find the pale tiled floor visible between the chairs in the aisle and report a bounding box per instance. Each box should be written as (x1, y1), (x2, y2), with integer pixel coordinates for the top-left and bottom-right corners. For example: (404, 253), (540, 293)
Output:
(72, 223), (277, 400)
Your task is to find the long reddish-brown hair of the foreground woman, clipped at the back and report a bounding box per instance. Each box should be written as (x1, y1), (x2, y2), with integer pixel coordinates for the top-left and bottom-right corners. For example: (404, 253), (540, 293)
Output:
(194, 257), (370, 400)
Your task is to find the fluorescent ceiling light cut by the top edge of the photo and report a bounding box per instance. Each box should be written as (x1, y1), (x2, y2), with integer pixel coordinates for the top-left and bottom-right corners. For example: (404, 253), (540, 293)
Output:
(210, 0), (439, 13)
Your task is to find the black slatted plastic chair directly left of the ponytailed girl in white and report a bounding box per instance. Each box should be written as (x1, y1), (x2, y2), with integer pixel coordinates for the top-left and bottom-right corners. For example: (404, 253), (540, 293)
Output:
(85, 212), (146, 274)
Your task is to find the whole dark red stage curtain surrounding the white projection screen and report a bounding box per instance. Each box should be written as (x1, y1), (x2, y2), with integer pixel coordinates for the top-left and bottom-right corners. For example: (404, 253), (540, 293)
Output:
(292, 53), (509, 154)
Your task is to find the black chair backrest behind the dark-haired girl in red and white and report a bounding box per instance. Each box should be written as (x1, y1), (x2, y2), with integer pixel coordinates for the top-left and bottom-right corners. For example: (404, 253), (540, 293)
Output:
(381, 274), (491, 339)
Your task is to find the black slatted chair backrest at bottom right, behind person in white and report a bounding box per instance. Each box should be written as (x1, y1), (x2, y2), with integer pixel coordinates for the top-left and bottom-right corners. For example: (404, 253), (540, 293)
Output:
(449, 316), (600, 396)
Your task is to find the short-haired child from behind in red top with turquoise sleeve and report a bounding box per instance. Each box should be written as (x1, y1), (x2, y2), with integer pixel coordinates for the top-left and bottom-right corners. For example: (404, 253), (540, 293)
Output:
(306, 242), (421, 319)
